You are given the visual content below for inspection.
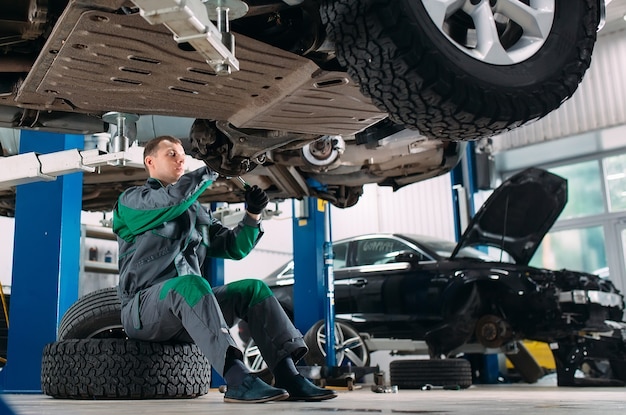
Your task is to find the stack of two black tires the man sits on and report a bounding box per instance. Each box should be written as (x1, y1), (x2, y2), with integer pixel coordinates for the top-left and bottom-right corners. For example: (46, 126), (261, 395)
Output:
(41, 287), (211, 399)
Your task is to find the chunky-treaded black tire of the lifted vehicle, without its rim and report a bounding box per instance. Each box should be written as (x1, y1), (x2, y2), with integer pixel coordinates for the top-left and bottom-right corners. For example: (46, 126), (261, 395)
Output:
(320, 0), (599, 140)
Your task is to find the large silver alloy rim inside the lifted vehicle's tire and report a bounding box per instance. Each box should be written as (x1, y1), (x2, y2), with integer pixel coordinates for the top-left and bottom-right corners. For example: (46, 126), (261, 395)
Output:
(422, 0), (555, 65)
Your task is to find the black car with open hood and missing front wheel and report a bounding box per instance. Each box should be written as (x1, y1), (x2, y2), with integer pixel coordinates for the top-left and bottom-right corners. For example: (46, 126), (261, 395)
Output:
(241, 168), (626, 385)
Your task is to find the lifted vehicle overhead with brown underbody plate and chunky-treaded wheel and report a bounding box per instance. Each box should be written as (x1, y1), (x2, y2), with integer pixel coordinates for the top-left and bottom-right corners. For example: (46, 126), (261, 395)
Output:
(0, 0), (604, 215)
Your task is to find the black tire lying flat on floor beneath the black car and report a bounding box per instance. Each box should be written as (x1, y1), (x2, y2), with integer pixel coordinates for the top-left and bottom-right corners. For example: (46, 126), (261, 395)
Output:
(389, 359), (472, 389)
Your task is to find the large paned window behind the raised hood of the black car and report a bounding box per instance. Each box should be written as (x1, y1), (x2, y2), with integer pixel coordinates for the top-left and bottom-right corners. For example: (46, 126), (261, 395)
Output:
(498, 138), (626, 289)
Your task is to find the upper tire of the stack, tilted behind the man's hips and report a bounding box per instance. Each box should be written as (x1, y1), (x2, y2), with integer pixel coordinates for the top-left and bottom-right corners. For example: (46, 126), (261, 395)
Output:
(58, 287), (126, 340)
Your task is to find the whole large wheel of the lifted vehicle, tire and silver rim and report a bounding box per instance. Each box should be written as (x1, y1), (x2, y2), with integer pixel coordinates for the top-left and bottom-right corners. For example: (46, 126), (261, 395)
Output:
(321, 0), (599, 140)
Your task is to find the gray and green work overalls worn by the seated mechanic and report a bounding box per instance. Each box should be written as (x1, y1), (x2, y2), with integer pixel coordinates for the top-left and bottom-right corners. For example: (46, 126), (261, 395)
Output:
(113, 167), (307, 375)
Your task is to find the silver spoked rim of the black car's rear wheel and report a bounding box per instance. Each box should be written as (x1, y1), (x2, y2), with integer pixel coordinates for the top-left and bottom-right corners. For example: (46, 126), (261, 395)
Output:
(316, 323), (369, 367)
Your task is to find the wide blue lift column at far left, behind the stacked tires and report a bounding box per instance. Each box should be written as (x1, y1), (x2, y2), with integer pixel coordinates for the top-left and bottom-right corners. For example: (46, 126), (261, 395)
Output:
(0, 130), (84, 393)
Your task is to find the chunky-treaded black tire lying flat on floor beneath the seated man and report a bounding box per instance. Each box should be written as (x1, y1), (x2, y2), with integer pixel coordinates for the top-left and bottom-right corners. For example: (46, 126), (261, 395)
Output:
(41, 339), (211, 399)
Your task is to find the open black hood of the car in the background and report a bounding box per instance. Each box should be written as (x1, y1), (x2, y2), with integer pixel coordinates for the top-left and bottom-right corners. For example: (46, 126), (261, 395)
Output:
(451, 168), (567, 265)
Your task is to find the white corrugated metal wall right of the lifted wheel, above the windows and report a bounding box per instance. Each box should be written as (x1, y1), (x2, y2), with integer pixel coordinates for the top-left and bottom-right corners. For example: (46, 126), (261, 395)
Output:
(493, 31), (626, 153)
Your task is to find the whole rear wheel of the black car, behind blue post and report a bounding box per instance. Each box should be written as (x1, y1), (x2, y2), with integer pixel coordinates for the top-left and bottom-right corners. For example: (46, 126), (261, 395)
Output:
(304, 320), (370, 367)
